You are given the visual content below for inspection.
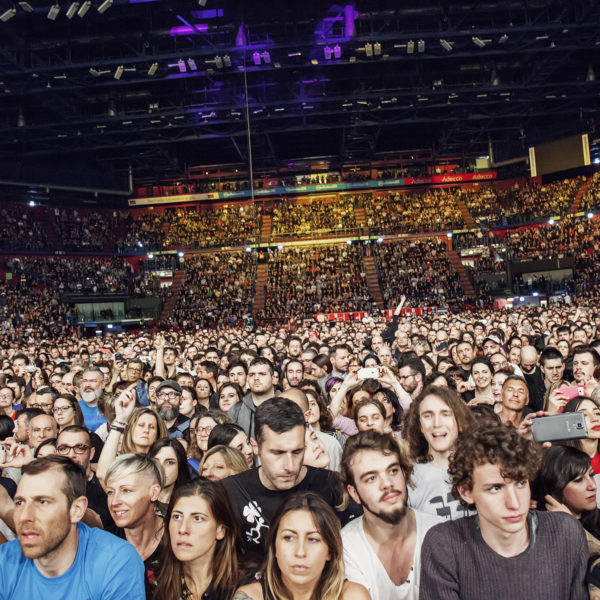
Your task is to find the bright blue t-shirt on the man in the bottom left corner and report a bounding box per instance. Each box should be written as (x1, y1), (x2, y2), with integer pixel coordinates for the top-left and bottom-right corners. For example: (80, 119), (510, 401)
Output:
(0, 523), (146, 600)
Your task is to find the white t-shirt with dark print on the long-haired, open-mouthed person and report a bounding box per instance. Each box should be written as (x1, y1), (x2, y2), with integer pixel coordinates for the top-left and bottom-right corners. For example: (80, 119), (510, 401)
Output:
(408, 461), (475, 520)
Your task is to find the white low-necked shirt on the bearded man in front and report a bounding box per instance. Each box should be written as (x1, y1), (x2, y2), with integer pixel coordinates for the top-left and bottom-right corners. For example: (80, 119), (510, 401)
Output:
(342, 511), (444, 600)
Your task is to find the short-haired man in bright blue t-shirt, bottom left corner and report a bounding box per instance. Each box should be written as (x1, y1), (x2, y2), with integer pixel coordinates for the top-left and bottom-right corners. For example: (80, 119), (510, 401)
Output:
(0, 455), (145, 600)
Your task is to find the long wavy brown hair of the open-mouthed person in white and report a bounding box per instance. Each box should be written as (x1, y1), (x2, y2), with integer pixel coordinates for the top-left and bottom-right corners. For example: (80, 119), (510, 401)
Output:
(404, 385), (475, 463)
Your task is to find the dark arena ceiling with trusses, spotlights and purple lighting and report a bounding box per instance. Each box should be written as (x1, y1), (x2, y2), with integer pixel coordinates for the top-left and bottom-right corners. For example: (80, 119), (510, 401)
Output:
(0, 0), (600, 190)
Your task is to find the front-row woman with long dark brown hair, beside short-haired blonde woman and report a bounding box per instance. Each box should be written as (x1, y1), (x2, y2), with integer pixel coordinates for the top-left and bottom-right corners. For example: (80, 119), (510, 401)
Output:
(153, 479), (239, 600)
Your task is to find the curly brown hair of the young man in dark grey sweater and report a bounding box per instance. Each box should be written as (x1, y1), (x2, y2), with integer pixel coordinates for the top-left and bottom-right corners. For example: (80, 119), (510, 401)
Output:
(448, 423), (540, 510)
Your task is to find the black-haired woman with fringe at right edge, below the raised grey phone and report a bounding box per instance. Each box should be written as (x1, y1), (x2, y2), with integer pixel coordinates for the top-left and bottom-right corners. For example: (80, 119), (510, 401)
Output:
(532, 444), (600, 554)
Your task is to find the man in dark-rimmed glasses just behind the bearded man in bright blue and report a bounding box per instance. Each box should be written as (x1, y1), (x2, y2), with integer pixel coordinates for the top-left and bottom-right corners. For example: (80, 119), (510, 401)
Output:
(56, 425), (116, 533)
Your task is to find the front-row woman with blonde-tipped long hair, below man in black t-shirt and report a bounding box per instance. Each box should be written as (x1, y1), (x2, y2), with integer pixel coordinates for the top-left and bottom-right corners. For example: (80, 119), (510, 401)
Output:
(234, 492), (371, 600)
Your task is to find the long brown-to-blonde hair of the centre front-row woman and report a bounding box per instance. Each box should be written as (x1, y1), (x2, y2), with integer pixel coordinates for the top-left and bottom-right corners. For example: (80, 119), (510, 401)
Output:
(263, 492), (344, 600)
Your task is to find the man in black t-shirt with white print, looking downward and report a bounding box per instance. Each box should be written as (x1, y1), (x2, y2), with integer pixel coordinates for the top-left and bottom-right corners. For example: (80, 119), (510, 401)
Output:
(223, 398), (355, 563)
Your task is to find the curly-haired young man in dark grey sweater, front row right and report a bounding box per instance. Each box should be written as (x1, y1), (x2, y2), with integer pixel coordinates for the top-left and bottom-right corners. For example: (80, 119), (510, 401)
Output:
(419, 425), (588, 600)
